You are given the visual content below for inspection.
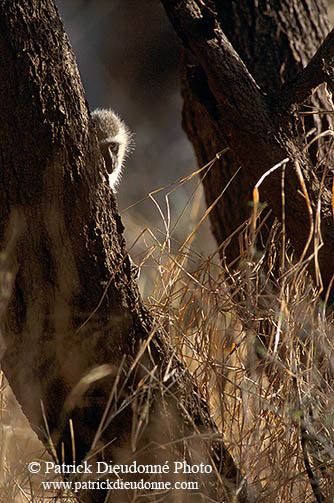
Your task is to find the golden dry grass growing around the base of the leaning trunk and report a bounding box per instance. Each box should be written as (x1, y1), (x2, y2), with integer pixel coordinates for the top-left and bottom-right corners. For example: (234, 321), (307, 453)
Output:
(0, 149), (334, 503)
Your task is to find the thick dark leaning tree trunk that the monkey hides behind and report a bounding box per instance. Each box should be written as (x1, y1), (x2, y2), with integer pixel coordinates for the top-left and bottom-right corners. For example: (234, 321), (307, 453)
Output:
(0, 0), (249, 502)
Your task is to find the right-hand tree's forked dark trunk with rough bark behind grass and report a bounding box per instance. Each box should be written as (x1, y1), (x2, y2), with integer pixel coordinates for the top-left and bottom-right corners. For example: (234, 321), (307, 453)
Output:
(162, 0), (334, 301)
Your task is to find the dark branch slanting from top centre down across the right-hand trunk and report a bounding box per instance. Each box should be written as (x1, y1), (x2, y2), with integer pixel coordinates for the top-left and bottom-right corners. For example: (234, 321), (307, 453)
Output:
(162, 0), (334, 300)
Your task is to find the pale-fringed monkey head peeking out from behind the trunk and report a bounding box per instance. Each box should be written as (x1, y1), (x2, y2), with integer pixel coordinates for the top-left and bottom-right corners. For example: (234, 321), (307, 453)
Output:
(92, 108), (133, 190)
